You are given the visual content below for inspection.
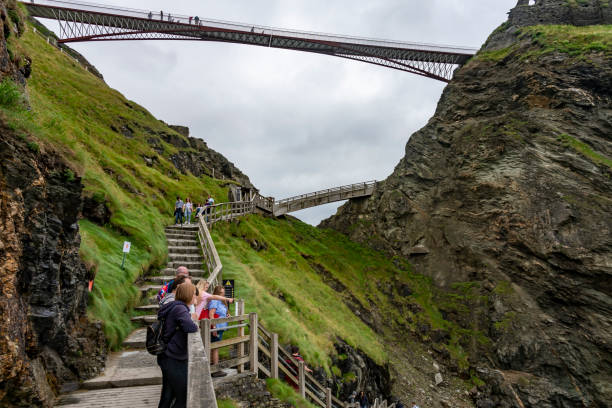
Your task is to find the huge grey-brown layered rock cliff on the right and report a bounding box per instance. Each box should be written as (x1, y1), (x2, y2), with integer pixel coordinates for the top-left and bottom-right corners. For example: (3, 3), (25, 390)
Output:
(322, 1), (612, 407)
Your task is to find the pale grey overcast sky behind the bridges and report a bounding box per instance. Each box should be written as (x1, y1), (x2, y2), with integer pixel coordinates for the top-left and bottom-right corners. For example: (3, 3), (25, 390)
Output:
(38, 0), (516, 225)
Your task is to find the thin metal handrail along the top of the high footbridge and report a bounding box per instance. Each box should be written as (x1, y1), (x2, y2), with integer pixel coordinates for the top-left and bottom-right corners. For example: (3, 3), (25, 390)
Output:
(21, 0), (478, 55)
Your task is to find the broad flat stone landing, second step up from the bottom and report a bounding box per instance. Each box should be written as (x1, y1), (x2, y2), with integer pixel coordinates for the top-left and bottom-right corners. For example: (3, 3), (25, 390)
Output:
(82, 350), (162, 390)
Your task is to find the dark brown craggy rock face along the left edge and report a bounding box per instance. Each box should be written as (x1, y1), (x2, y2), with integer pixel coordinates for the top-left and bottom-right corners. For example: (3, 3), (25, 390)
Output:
(0, 0), (106, 407)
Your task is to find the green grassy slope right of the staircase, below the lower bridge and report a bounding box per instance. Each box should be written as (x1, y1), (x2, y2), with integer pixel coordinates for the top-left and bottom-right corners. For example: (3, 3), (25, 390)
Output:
(213, 215), (484, 371)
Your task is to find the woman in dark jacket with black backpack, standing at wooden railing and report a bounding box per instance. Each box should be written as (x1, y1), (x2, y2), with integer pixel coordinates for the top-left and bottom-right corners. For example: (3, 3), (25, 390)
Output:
(157, 282), (198, 408)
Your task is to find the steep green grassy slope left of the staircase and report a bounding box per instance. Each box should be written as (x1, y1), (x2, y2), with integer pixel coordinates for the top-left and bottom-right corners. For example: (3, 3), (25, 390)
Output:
(2, 21), (232, 346)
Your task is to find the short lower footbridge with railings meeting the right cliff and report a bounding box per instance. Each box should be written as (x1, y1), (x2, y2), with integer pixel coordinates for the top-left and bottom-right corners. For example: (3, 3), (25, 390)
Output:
(268, 181), (376, 217)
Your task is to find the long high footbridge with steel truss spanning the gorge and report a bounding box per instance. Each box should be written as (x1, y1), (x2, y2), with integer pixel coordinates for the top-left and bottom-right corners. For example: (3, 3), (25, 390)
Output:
(22, 0), (477, 82)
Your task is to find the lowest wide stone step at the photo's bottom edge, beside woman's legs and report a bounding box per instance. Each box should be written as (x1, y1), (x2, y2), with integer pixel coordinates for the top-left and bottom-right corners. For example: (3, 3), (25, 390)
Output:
(55, 385), (161, 408)
